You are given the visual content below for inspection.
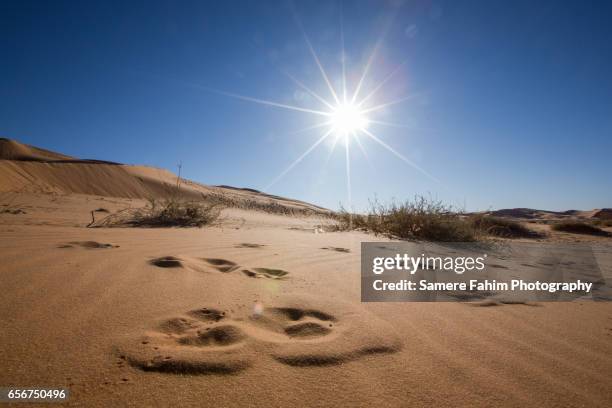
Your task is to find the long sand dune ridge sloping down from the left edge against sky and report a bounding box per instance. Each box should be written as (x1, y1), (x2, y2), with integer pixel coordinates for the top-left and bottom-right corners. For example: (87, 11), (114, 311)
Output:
(0, 138), (328, 212)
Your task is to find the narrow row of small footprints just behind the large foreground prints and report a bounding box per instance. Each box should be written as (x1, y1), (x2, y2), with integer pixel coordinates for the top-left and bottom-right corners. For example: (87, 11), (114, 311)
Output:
(149, 256), (289, 279)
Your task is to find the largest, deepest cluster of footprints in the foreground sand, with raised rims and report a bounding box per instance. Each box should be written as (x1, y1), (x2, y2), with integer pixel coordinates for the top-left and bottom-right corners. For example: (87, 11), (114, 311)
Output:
(117, 305), (401, 374)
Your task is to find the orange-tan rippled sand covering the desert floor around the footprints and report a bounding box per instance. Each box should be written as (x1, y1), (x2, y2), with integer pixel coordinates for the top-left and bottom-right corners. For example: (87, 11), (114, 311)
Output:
(0, 139), (612, 407)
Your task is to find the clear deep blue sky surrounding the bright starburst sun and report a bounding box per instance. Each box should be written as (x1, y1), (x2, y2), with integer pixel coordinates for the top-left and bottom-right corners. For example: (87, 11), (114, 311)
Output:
(0, 1), (612, 210)
